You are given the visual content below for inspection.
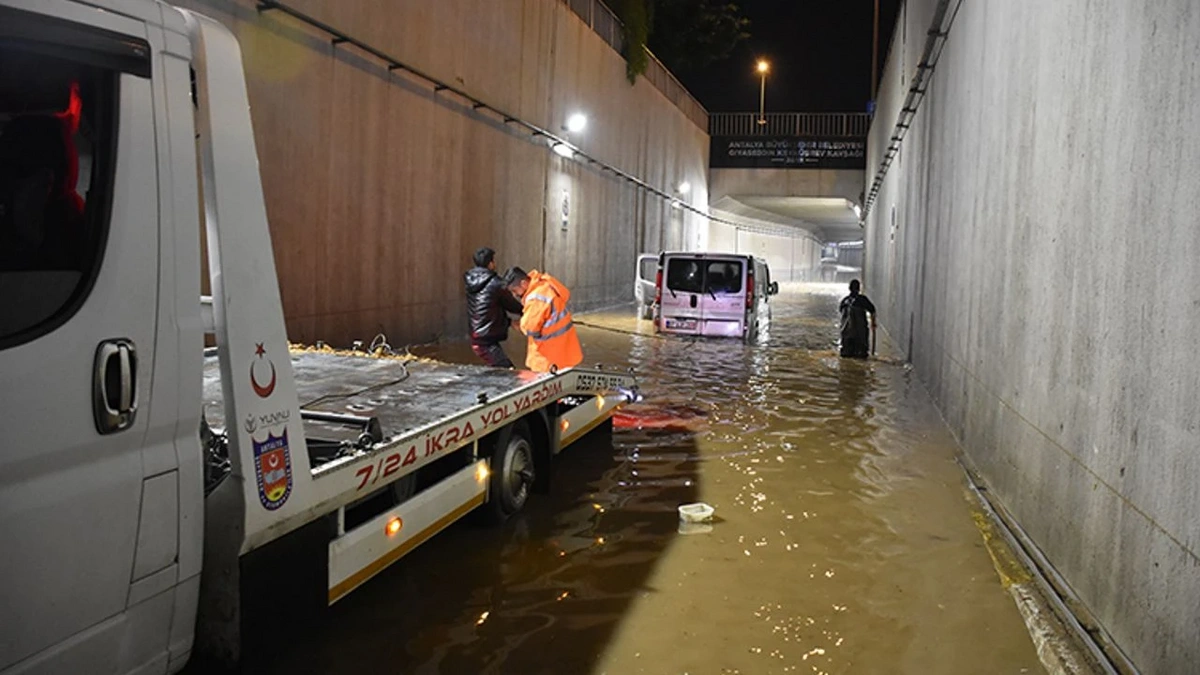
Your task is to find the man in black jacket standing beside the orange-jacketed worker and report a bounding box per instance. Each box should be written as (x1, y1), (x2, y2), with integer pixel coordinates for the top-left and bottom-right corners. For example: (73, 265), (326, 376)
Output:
(464, 246), (522, 368)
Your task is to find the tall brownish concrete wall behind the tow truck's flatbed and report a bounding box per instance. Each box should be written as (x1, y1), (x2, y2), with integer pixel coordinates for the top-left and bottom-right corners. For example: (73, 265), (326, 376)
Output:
(180, 0), (708, 345)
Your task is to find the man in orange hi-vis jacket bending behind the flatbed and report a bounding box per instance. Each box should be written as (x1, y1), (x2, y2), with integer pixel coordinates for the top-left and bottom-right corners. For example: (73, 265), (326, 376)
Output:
(504, 267), (583, 372)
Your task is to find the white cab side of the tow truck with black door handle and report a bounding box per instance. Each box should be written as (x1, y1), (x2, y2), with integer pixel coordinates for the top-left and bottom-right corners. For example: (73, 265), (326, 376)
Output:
(0, 5), (164, 673)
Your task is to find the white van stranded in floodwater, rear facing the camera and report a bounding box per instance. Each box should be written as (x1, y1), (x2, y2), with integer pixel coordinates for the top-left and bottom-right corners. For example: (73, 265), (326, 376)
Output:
(654, 252), (779, 340)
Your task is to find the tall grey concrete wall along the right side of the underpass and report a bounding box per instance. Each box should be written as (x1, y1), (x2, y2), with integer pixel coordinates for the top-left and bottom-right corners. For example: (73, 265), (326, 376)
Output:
(866, 0), (1200, 673)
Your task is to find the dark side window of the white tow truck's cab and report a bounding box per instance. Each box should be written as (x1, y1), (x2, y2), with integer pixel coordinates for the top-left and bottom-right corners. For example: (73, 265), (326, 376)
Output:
(0, 8), (127, 348)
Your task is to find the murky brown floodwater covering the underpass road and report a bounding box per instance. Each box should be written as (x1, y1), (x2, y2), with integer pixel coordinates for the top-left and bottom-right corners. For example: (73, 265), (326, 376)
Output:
(248, 286), (1042, 675)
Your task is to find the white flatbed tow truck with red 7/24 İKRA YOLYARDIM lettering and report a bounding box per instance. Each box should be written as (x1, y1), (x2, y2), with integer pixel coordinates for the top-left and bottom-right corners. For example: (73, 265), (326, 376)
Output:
(0, 0), (636, 675)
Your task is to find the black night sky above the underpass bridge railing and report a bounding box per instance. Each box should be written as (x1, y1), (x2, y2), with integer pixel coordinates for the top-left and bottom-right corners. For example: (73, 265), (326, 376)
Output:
(676, 0), (900, 113)
